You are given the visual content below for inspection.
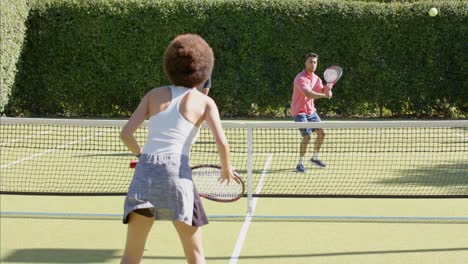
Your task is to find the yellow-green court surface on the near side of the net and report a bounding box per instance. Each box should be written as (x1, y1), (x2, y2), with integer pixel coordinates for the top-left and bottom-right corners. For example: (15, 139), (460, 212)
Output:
(1, 195), (468, 264)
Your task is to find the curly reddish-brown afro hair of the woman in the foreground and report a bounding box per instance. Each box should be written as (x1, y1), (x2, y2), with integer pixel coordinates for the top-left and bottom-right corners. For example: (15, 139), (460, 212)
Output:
(164, 34), (214, 88)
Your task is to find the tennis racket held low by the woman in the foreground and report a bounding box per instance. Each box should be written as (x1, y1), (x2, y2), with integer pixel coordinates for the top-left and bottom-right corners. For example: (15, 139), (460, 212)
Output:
(130, 160), (245, 203)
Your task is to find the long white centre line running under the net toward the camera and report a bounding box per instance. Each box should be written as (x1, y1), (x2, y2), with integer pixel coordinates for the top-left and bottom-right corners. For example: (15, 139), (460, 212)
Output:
(229, 154), (273, 264)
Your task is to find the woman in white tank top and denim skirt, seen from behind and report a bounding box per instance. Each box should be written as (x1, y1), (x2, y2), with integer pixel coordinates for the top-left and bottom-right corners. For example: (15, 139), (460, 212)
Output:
(120, 34), (234, 263)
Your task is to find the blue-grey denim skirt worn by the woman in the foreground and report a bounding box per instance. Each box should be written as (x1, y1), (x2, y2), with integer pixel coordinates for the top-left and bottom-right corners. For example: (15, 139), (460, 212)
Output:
(123, 153), (208, 226)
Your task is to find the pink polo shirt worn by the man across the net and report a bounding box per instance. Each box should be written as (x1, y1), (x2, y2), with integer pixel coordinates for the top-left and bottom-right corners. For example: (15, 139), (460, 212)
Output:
(291, 70), (323, 116)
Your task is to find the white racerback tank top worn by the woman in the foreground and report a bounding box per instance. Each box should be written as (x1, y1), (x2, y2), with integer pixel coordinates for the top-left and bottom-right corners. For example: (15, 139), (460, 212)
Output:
(143, 85), (199, 156)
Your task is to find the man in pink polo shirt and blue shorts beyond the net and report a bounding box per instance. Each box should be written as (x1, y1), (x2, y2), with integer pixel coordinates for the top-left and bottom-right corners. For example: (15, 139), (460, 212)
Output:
(291, 53), (332, 172)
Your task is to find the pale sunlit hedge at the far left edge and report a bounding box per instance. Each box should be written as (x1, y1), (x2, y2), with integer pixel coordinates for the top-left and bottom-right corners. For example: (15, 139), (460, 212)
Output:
(0, 0), (29, 113)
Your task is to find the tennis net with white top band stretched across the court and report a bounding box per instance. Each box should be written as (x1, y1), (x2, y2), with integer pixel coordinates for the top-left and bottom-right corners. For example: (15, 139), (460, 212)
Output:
(0, 118), (468, 198)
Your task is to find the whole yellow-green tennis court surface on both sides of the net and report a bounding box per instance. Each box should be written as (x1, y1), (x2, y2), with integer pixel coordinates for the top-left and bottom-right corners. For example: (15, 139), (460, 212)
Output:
(0, 119), (468, 264)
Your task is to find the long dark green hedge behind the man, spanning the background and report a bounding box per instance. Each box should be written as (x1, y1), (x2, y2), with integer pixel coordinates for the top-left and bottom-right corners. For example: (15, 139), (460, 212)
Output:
(4, 0), (468, 117)
